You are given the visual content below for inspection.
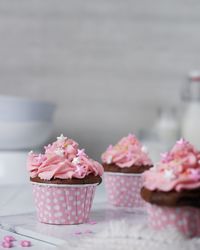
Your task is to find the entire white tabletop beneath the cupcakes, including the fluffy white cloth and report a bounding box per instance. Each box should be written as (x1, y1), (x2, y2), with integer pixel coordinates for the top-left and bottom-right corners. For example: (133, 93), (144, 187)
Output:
(0, 185), (200, 250)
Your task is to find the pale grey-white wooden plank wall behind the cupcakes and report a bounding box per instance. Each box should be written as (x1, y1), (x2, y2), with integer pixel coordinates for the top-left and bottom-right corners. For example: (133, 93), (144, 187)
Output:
(0, 0), (200, 158)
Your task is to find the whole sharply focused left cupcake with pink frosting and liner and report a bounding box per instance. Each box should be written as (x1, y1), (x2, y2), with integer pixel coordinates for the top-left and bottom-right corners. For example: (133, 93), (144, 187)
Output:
(27, 135), (103, 224)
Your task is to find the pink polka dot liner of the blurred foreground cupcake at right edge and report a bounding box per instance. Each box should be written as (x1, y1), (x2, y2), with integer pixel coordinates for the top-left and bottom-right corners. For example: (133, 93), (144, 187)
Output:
(147, 204), (200, 238)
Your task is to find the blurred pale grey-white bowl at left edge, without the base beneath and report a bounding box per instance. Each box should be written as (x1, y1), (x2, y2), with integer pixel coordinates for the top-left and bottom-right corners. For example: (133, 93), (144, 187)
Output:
(0, 96), (55, 150)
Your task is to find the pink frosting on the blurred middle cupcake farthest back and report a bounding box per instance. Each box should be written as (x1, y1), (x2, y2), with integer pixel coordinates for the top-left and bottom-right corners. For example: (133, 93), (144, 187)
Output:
(101, 134), (152, 168)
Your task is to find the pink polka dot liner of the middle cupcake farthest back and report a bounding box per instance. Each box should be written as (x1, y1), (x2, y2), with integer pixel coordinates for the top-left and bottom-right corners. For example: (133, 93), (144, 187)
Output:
(104, 172), (146, 209)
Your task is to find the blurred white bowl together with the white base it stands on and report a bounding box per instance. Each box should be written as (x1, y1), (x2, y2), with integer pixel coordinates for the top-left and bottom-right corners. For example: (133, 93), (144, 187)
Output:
(0, 96), (55, 185)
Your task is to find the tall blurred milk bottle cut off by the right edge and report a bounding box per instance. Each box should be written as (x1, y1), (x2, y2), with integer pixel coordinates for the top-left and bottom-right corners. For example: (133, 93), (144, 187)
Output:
(181, 71), (200, 149)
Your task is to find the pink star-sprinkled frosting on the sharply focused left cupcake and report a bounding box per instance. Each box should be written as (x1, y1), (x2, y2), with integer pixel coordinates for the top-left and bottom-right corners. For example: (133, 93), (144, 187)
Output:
(27, 135), (103, 180)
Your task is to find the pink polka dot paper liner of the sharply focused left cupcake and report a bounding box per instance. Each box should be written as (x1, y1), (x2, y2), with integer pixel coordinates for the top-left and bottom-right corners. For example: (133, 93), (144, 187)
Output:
(32, 183), (97, 225)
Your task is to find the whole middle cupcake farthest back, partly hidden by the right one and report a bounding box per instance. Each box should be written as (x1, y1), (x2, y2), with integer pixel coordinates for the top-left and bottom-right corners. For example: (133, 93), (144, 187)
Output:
(102, 134), (152, 208)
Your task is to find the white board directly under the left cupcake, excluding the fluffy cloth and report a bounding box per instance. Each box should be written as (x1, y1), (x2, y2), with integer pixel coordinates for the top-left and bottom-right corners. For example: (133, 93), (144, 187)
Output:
(0, 202), (146, 247)
